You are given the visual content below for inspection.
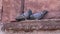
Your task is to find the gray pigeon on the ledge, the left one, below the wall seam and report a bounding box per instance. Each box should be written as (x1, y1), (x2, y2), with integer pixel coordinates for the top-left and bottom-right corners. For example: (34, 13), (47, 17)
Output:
(16, 9), (32, 21)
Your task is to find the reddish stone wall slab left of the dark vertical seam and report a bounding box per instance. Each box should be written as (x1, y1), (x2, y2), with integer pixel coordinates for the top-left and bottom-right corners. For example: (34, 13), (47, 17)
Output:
(3, 0), (21, 22)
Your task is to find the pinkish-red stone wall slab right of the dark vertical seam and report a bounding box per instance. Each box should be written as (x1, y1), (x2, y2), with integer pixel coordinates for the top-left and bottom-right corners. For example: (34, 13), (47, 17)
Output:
(25, 0), (60, 19)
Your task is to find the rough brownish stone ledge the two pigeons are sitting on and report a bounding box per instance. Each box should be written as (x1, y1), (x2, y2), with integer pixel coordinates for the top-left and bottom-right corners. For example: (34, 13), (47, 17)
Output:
(2, 19), (60, 31)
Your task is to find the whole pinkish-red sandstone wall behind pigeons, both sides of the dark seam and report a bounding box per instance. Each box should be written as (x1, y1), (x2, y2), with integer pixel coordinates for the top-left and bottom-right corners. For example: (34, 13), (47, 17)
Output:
(3, 0), (60, 22)
